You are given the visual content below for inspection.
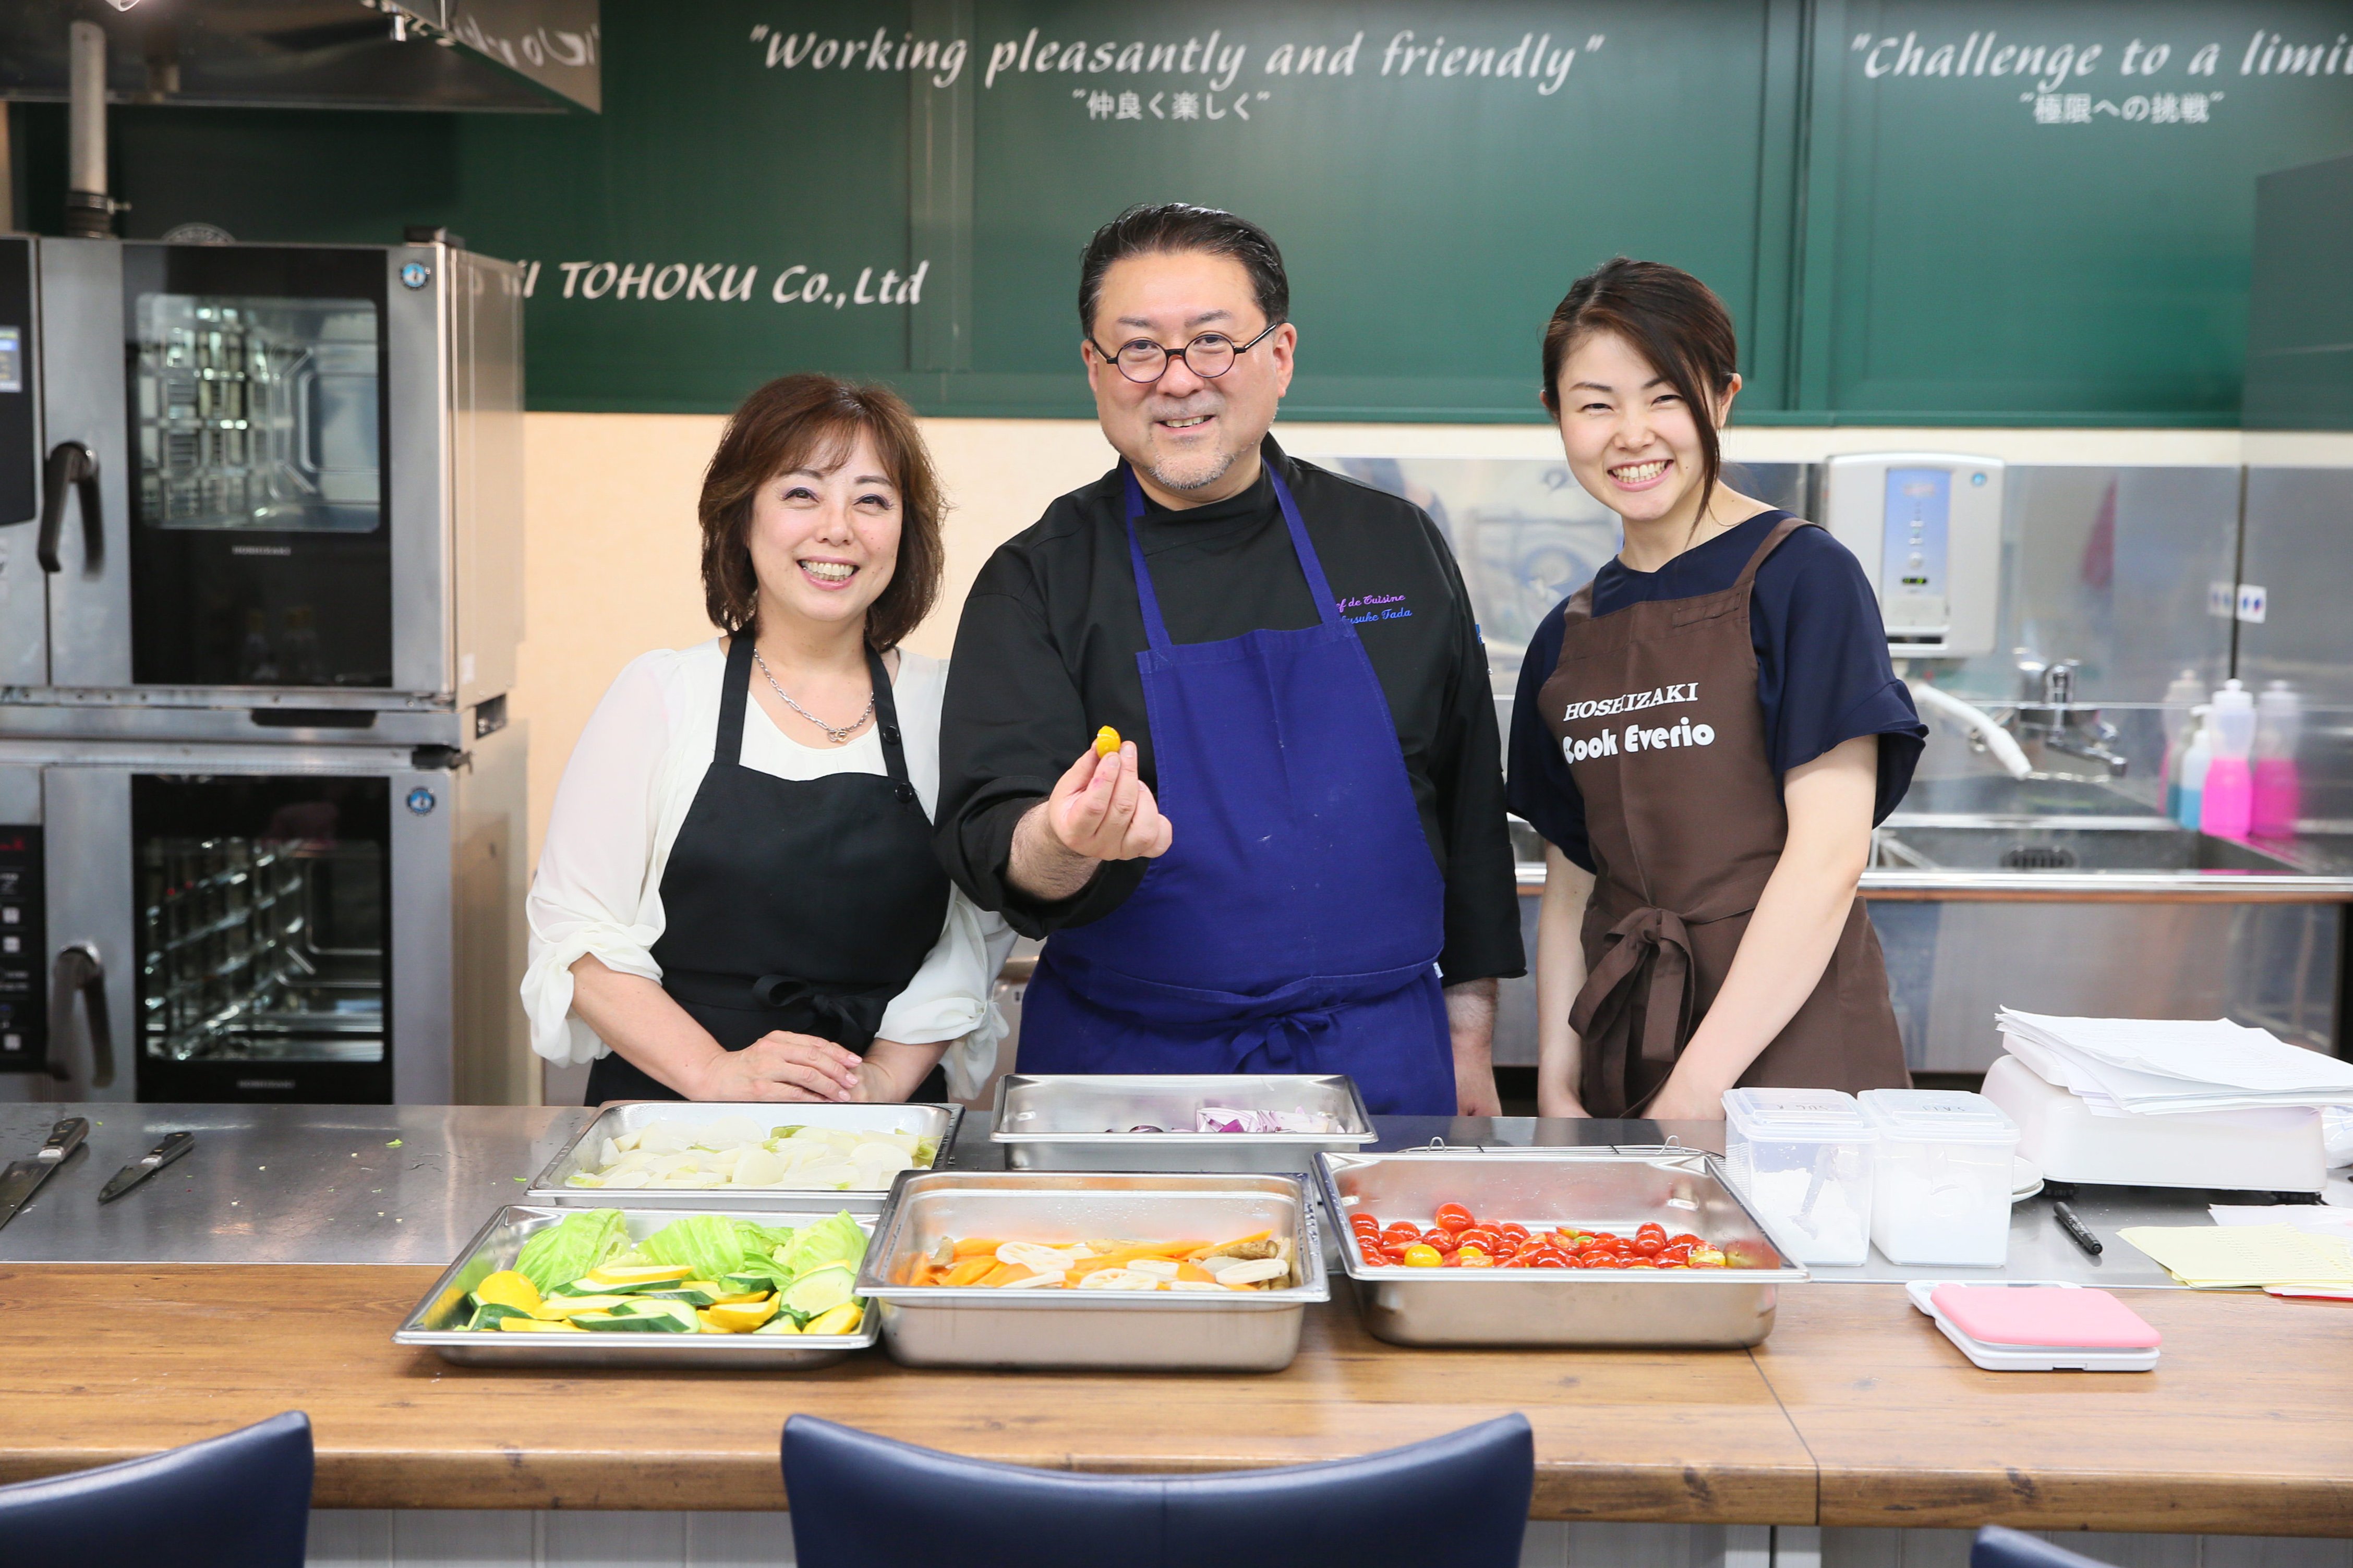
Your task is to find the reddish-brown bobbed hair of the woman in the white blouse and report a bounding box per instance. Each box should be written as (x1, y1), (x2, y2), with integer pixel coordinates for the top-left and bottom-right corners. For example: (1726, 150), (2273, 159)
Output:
(694, 374), (946, 649)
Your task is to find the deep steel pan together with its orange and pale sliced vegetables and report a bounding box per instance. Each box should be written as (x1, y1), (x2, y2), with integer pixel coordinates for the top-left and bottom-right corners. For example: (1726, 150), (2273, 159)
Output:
(856, 1171), (1332, 1373)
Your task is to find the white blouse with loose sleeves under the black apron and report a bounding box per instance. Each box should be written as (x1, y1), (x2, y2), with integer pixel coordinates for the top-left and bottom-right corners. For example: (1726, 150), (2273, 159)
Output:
(522, 637), (1014, 1098)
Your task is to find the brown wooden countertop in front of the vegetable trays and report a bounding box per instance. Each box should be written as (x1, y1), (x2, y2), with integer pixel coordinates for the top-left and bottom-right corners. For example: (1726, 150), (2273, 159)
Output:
(0, 1265), (2353, 1535)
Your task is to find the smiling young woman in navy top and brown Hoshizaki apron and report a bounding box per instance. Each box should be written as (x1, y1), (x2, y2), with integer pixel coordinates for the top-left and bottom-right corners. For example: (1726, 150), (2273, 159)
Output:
(1511, 259), (1927, 1119)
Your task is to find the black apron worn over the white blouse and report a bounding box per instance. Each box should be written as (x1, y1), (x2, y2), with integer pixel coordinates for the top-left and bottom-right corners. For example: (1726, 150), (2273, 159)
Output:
(586, 633), (948, 1105)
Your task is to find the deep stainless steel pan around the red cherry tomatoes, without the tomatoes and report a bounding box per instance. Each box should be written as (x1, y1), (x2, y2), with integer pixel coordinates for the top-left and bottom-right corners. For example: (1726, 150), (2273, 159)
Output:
(1316, 1150), (1809, 1347)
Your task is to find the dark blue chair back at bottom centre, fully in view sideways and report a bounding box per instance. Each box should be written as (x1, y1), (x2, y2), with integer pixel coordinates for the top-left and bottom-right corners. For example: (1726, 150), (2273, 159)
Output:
(783, 1415), (1537, 1568)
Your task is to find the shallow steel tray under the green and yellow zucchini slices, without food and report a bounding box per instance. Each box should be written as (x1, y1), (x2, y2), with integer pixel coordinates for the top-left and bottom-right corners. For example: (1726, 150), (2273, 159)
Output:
(393, 1204), (883, 1368)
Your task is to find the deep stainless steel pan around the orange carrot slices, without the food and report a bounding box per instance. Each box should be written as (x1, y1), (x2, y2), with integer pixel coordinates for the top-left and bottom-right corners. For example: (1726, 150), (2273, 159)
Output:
(859, 1171), (1332, 1373)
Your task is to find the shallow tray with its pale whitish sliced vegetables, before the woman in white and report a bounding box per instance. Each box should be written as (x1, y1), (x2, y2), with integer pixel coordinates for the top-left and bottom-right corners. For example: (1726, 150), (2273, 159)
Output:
(522, 1100), (965, 1213)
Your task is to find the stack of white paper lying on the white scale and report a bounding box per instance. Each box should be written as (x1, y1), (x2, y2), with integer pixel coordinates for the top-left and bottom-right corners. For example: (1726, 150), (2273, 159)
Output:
(1998, 1008), (2353, 1116)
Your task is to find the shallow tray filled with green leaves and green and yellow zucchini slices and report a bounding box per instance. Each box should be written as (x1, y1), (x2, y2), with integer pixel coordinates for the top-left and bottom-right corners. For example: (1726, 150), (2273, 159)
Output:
(393, 1204), (878, 1368)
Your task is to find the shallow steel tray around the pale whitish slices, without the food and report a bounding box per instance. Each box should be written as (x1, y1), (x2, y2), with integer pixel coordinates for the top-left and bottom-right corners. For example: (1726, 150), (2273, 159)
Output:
(522, 1100), (965, 1213)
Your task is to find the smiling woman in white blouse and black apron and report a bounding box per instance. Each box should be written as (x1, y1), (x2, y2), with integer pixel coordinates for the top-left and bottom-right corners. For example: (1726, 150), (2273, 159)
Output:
(522, 376), (1012, 1105)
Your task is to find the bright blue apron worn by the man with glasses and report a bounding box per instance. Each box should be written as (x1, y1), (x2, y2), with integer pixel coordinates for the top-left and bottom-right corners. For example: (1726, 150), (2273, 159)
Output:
(1021, 463), (1456, 1116)
